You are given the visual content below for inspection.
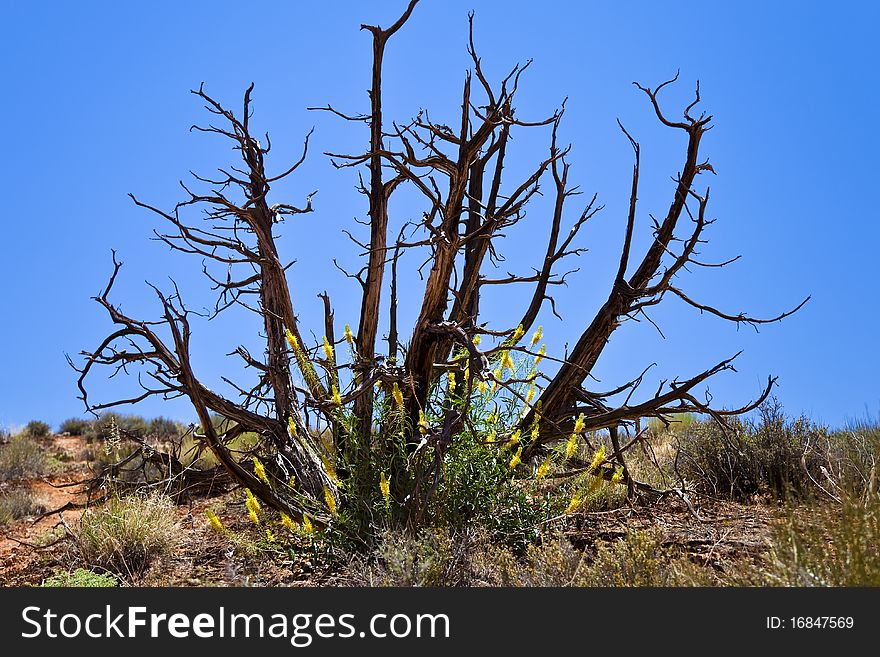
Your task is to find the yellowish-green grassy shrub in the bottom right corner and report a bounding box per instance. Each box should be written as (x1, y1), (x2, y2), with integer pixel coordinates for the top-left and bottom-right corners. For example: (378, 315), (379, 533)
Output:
(758, 494), (880, 586)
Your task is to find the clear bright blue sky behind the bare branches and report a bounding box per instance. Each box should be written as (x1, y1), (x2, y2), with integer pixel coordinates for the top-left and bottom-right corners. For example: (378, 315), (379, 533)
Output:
(0, 0), (880, 427)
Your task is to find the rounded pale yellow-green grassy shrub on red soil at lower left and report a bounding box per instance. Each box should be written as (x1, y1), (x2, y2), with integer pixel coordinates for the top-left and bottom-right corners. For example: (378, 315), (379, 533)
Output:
(73, 493), (179, 578)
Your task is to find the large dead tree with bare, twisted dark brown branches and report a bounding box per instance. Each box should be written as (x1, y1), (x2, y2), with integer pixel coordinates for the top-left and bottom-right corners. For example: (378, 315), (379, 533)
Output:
(79, 0), (806, 522)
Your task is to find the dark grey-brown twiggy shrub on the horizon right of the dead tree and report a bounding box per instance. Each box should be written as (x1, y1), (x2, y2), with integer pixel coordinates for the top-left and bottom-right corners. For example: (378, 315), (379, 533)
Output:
(674, 402), (835, 500)
